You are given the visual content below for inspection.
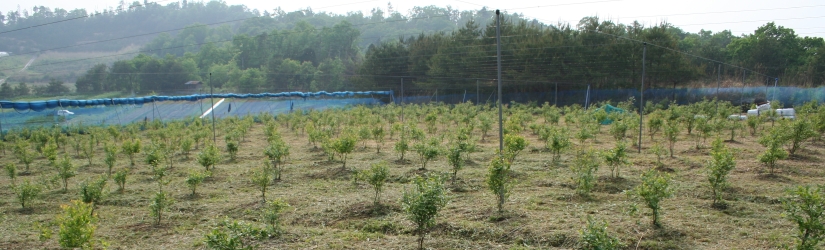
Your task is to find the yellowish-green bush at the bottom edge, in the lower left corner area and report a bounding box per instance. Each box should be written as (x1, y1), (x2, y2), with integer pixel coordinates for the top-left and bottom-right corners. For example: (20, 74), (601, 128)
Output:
(57, 201), (97, 249)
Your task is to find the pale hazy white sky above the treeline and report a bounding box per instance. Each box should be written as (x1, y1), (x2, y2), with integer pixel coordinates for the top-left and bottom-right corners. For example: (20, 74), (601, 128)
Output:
(0, 0), (825, 37)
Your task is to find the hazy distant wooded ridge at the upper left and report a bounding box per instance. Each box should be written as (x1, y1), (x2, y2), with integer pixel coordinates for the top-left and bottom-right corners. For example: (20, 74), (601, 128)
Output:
(0, 0), (255, 54)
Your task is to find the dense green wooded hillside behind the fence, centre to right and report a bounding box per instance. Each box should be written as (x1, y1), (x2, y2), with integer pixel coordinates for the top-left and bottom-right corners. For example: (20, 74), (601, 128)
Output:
(0, 2), (825, 98)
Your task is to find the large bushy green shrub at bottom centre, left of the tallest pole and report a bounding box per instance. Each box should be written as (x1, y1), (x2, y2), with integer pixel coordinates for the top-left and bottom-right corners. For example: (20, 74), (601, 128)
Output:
(401, 177), (448, 249)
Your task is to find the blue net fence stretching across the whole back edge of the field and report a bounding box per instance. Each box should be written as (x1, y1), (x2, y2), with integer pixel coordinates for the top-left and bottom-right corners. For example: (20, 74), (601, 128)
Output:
(0, 82), (825, 130)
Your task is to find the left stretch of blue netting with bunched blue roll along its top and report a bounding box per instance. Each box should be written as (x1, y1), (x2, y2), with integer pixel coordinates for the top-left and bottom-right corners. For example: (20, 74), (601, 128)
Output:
(0, 91), (393, 130)
